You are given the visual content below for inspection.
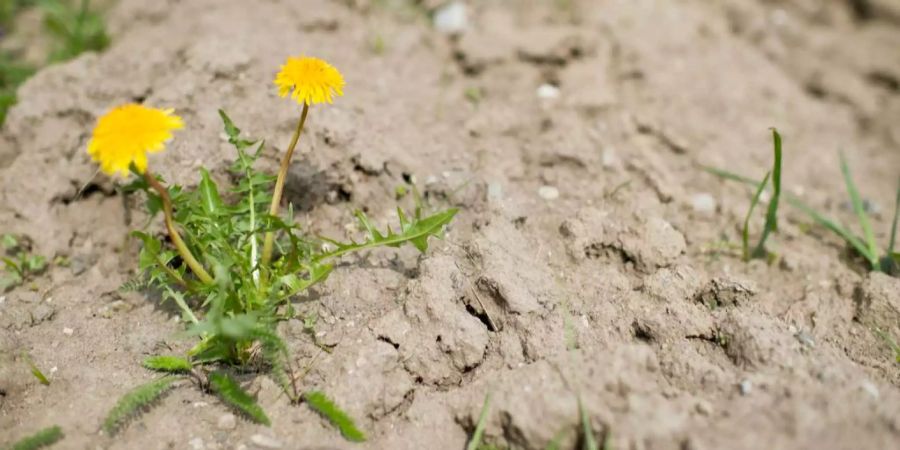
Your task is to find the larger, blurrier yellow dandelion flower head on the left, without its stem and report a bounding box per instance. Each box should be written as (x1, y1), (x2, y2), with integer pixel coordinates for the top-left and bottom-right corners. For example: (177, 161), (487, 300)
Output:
(88, 103), (184, 177)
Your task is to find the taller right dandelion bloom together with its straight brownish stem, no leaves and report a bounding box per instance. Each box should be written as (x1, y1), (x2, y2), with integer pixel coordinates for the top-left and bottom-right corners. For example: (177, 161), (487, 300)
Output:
(261, 56), (344, 272)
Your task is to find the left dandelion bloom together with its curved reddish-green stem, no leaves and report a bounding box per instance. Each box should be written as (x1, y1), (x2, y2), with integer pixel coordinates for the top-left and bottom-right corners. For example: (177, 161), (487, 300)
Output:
(88, 103), (213, 284)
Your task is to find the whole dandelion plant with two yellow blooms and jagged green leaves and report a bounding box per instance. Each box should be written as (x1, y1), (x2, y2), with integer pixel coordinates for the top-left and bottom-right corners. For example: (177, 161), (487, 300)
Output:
(94, 57), (457, 441)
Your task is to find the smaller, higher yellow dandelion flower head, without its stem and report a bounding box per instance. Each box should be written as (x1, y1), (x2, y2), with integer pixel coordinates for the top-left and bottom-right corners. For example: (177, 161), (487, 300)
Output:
(275, 56), (344, 106)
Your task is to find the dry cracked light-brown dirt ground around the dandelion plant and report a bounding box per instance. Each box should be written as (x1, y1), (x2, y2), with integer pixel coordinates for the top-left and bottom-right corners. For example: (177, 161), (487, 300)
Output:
(0, 0), (900, 450)
